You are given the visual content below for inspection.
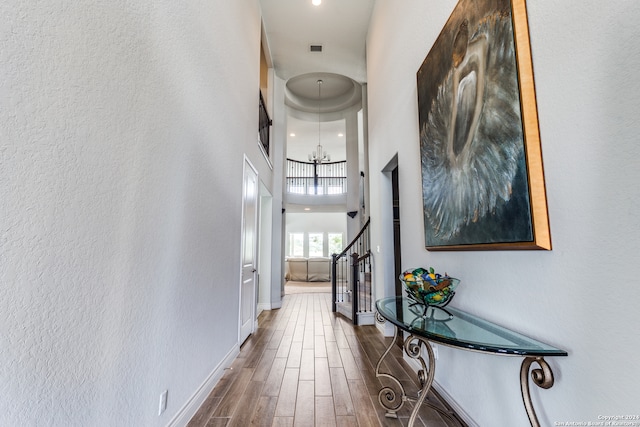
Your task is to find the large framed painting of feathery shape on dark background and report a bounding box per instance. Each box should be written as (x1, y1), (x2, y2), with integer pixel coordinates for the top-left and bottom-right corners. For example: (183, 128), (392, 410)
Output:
(417, 0), (551, 250)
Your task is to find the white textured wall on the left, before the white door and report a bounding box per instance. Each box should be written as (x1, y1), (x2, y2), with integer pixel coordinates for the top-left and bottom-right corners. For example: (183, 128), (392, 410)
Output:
(0, 0), (265, 426)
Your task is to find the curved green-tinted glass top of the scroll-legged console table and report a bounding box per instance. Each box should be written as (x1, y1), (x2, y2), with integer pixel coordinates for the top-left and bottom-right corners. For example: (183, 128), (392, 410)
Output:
(376, 297), (567, 356)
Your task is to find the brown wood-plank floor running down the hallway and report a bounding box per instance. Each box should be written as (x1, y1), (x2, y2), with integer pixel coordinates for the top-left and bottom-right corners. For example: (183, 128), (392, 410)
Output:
(188, 293), (459, 427)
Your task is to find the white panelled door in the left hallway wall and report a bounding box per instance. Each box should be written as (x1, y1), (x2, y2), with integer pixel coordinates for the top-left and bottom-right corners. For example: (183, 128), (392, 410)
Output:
(239, 158), (258, 343)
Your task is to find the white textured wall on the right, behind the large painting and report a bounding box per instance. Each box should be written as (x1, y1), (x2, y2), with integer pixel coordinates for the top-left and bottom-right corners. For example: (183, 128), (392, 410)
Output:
(367, 0), (640, 427)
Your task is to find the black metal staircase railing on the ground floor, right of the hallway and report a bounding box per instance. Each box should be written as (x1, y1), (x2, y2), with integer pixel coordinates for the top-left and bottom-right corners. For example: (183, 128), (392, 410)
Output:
(331, 218), (373, 325)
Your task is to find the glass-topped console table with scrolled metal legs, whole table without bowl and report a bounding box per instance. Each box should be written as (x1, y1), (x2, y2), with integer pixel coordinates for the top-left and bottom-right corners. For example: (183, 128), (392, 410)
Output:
(376, 297), (567, 427)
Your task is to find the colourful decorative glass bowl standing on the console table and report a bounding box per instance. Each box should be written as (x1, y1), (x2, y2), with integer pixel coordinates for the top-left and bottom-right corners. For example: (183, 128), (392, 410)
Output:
(400, 268), (460, 307)
